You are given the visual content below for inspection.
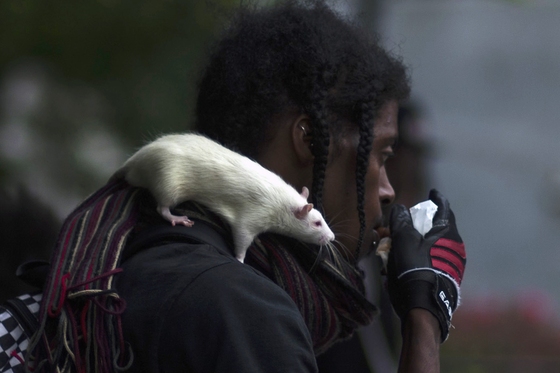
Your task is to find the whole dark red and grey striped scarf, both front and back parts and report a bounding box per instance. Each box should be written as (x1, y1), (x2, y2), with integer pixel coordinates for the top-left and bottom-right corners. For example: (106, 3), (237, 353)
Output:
(26, 181), (377, 373)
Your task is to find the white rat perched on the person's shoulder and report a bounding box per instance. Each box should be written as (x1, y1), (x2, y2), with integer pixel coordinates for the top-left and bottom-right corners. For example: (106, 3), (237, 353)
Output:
(112, 134), (334, 262)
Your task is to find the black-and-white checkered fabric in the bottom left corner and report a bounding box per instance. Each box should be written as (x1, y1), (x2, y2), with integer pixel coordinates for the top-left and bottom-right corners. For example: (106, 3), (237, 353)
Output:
(0, 294), (42, 373)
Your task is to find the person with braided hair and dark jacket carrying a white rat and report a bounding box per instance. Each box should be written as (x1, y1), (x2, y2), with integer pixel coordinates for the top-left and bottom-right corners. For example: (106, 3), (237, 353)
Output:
(25, 2), (465, 372)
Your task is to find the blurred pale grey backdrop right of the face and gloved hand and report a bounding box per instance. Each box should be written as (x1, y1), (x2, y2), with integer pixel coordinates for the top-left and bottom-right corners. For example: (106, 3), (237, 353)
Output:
(380, 1), (560, 312)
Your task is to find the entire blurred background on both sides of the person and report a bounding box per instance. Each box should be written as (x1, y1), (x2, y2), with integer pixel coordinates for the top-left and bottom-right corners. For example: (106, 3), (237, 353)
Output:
(0, 0), (560, 372)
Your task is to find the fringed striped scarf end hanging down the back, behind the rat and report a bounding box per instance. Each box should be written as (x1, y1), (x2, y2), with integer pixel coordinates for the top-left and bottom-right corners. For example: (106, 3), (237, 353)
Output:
(25, 182), (138, 373)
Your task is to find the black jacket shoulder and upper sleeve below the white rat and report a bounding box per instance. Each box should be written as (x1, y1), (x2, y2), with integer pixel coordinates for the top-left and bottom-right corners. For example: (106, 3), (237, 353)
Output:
(119, 240), (315, 372)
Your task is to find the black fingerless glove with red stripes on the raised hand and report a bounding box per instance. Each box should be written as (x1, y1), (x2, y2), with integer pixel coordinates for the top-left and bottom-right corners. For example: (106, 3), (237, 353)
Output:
(387, 189), (467, 342)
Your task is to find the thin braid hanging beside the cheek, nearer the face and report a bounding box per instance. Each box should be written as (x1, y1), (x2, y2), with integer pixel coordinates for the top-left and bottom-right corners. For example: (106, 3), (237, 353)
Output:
(356, 100), (374, 256)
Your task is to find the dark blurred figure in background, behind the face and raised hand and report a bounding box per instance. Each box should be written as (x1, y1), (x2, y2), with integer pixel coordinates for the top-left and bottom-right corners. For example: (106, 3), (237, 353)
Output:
(317, 98), (438, 373)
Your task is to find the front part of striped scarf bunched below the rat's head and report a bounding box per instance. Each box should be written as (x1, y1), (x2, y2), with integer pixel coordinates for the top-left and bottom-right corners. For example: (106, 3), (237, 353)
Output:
(245, 233), (377, 355)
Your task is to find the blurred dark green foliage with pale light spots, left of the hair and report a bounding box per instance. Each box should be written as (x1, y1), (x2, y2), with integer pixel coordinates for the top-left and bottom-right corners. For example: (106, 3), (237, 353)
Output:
(0, 0), (239, 214)
